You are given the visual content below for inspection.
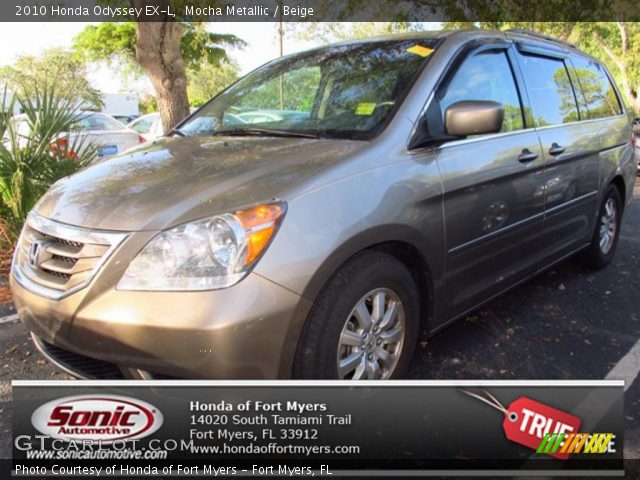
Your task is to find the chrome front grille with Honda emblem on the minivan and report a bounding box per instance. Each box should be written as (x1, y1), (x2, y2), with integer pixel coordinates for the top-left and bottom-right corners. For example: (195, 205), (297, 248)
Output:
(14, 213), (126, 299)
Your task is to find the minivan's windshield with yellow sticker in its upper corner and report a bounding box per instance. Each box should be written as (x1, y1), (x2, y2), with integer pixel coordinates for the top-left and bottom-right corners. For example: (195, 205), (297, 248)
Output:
(179, 38), (438, 139)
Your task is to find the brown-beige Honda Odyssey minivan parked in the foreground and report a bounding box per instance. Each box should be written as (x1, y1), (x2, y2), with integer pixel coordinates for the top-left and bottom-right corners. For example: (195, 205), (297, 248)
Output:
(11, 31), (637, 379)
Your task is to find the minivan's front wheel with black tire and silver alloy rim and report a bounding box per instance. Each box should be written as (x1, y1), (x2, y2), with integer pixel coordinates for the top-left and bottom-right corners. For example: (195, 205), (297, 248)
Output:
(293, 250), (419, 380)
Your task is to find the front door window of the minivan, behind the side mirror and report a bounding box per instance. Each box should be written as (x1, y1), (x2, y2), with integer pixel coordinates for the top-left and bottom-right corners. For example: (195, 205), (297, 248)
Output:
(440, 50), (524, 132)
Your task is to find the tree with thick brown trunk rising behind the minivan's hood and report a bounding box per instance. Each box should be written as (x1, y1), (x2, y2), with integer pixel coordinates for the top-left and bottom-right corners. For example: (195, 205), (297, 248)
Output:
(74, 15), (244, 130)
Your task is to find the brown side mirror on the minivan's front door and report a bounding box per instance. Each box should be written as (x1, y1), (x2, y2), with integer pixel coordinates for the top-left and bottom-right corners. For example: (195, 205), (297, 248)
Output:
(444, 100), (504, 137)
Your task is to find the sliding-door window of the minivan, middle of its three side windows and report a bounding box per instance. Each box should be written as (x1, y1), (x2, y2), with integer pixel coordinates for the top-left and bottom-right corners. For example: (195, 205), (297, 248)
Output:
(520, 55), (580, 127)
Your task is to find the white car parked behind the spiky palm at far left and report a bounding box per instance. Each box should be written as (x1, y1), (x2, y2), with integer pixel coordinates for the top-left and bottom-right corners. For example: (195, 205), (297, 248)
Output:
(13, 112), (144, 159)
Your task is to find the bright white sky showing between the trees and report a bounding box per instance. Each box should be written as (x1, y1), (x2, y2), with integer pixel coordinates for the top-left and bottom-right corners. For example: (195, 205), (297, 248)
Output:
(0, 22), (317, 93)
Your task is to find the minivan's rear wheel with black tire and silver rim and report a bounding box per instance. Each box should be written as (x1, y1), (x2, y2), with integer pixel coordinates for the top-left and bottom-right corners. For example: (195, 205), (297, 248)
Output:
(580, 185), (622, 270)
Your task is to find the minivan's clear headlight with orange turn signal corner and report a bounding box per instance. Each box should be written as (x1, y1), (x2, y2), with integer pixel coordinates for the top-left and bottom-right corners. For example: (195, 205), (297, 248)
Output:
(118, 203), (286, 290)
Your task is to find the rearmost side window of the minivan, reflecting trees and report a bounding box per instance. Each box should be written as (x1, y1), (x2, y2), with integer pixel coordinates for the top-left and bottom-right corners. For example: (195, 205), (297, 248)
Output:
(572, 57), (622, 118)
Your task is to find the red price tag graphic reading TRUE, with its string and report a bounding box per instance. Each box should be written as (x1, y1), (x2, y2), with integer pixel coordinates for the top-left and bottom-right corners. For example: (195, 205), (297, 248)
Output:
(464, 391), (582, 460)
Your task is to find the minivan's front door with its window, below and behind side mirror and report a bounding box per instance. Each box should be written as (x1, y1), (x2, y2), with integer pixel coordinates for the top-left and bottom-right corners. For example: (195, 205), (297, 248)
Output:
(437, 48), (544, 318)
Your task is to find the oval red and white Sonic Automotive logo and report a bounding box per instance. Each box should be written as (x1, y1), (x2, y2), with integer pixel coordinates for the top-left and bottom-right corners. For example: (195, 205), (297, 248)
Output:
(31, 395), (163, 444)
